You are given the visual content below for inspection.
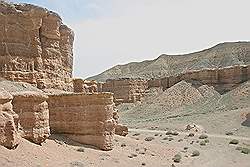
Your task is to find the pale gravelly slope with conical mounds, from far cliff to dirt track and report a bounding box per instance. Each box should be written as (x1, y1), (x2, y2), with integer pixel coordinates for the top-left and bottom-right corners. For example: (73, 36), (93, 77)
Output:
(118, 81), (250, 136)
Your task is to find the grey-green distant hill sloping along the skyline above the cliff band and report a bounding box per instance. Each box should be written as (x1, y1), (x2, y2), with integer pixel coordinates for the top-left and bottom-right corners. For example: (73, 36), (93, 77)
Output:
(88, 42), (250, 82)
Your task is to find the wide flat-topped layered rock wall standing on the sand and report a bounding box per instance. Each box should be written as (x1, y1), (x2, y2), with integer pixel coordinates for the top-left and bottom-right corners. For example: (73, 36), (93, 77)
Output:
(49, 93), (116, 150)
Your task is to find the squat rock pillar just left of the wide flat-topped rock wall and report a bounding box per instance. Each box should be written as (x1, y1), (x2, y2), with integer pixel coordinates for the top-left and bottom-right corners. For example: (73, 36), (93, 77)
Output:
(13, 91), (50, 144)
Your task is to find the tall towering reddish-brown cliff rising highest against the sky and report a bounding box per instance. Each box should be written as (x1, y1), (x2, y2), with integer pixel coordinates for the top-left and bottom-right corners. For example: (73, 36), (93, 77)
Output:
(0, 1), (74, 90)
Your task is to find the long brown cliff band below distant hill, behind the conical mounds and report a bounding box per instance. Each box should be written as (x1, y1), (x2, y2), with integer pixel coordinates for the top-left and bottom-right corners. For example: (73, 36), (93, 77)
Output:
(149, 65), (250, 93)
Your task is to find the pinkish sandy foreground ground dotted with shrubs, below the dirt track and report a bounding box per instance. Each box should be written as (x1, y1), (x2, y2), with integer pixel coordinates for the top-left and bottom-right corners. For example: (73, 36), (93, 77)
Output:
(0, 129), (250, 167)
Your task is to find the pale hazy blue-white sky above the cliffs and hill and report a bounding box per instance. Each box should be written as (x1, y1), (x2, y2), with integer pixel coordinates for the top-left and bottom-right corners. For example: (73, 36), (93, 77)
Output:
(13, 0), (250, 78)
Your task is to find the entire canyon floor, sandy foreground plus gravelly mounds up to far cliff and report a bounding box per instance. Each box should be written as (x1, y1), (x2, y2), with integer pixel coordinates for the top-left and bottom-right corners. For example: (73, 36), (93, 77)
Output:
(0, 81), (250, 167)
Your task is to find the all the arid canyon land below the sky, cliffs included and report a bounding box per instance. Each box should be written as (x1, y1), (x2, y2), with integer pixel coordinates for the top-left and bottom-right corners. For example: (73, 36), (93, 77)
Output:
(0, 1), (250, 167)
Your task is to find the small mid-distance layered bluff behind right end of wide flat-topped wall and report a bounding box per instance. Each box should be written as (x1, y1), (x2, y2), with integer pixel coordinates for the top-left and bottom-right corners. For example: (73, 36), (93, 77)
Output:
(102, 78), (148, 104)
